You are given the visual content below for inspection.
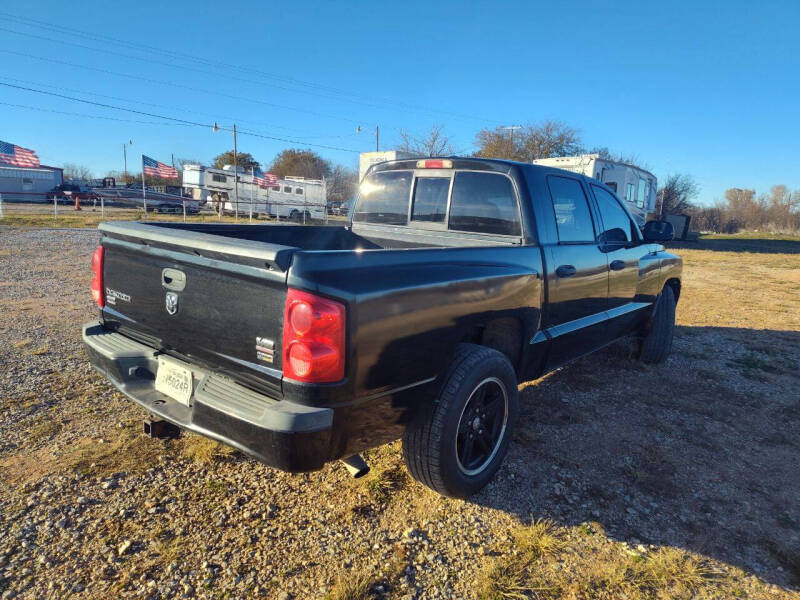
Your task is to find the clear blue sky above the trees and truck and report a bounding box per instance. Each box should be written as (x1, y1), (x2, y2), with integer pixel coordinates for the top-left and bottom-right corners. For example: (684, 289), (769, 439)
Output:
(0, 0), (800, 202)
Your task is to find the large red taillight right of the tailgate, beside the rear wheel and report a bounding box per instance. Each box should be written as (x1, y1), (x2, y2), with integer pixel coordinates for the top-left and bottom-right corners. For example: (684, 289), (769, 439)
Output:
(283, 288), (345, 383)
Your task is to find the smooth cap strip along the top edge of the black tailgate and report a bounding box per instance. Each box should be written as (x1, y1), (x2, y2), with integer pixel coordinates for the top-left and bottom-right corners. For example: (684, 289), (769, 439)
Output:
(97, 222), (297, 271)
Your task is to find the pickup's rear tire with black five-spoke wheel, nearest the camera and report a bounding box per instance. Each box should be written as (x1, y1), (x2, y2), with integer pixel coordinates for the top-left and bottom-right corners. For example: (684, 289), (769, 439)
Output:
(403, 344), (519, 498)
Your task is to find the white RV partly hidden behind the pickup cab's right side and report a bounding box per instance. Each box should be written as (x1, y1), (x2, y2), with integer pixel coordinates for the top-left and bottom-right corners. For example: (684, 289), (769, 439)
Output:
(533, 154), (658, 227)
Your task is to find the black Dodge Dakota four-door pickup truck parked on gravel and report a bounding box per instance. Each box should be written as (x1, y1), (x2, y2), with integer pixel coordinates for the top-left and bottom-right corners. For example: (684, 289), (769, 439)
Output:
(83, 157), (682, 497)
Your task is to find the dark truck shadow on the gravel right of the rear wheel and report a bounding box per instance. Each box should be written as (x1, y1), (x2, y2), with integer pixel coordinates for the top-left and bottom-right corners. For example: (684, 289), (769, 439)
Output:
(472, 327), (800, 589)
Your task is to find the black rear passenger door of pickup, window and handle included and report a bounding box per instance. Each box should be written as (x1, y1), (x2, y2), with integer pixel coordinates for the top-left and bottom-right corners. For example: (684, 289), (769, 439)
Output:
(543, 175), (608, 368)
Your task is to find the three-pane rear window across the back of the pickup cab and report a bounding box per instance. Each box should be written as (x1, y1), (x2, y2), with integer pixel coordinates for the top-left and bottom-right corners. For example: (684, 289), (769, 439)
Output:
(353, 171), (522, 236)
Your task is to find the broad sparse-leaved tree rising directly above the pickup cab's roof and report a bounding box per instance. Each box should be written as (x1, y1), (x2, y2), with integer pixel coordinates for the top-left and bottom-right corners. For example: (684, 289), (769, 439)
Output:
(475, 121), (583, 162)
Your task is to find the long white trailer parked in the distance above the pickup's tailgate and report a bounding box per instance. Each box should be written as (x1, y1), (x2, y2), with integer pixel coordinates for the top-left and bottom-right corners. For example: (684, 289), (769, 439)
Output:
(183, 165), (327, 220)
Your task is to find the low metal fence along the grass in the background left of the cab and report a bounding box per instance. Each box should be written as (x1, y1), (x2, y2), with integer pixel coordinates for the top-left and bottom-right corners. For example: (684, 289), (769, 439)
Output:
(0, 194), (341, 227)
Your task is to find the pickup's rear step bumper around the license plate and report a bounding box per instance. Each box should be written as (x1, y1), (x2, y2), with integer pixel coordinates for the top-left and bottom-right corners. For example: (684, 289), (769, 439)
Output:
(83, 321), (333, 472)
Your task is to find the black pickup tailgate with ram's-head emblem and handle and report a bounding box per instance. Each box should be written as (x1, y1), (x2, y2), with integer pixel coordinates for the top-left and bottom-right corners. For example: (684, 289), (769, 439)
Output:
(100, 223), (295, 397)
